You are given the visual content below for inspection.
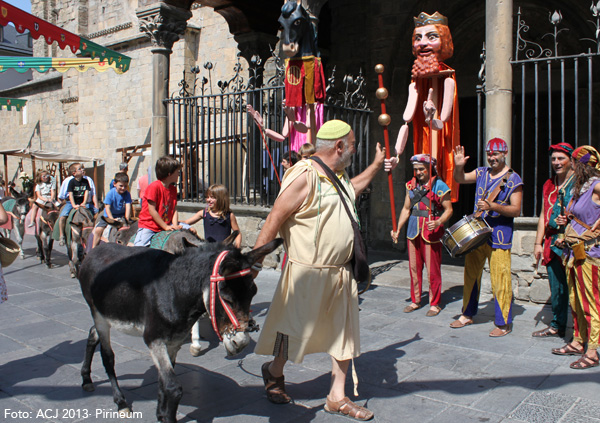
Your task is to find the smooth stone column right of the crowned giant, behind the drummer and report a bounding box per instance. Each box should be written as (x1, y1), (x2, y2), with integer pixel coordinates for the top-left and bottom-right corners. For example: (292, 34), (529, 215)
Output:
(484, 0), (513, 165)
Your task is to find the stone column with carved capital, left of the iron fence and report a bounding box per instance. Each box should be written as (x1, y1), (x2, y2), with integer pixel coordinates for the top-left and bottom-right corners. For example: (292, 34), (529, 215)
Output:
(136, 2), (192, 171)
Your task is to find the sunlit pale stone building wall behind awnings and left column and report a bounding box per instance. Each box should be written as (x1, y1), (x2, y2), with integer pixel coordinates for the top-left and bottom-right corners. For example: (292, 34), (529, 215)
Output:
(0, 0), (245, 197)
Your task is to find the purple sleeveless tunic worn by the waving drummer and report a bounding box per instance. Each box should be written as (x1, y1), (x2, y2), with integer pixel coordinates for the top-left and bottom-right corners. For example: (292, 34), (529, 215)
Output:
(474, 167), (523, 250)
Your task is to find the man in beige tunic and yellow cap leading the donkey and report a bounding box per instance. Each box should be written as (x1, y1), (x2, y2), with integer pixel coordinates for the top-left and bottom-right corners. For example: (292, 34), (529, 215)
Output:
(255, 120), (385, 420)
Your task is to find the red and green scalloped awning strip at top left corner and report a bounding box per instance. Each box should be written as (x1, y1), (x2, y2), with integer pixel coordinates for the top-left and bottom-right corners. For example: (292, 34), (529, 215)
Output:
(0, 0), (131, 73)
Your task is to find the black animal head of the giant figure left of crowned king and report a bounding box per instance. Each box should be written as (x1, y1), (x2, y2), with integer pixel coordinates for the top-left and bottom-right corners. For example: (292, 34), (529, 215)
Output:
(279, 0), (319, 57)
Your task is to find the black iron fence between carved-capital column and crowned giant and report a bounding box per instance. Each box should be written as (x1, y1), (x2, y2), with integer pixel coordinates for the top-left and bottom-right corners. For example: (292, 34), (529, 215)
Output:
(165, 65), (371, 207)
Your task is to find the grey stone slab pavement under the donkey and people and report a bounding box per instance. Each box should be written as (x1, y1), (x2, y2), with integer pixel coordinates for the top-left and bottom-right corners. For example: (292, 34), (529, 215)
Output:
(0, 237), (600, 423)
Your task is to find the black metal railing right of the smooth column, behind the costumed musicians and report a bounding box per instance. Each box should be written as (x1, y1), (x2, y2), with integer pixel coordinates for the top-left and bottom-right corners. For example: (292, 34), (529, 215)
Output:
(511, 8), (600, 216)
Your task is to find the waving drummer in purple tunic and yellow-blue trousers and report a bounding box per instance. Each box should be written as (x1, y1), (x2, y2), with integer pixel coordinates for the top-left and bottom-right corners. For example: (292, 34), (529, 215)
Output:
(450, 138), (523, 338)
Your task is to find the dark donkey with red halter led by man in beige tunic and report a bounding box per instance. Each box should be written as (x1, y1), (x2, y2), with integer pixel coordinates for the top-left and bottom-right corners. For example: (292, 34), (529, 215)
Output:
(79, 239), (282, 423)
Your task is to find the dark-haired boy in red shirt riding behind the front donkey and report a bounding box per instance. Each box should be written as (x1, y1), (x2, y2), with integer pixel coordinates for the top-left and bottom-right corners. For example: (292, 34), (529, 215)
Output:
(134, 156), (181, 247)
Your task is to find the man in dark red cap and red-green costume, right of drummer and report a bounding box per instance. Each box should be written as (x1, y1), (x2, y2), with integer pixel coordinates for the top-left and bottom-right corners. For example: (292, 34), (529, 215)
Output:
(531, 142), (575, 338)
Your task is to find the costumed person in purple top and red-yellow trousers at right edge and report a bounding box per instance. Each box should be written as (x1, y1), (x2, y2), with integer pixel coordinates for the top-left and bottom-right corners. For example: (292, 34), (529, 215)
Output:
(552, 145), (600, 370)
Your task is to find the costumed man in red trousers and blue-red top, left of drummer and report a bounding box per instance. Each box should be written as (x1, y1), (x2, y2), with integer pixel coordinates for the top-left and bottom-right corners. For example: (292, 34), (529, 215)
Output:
(391, 154), (452, 317)
